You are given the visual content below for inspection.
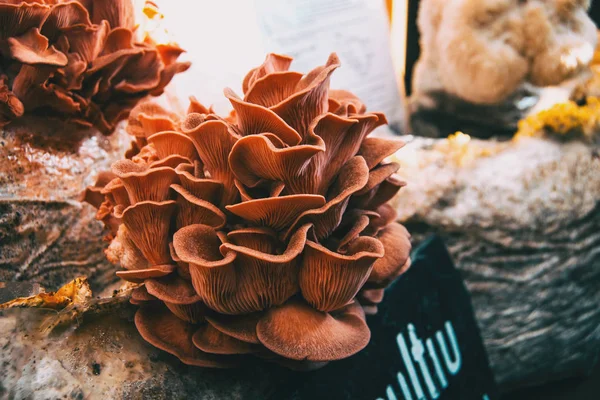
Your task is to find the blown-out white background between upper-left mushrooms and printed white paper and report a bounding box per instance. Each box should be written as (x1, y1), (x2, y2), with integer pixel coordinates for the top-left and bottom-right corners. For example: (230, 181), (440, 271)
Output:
(148, 0), (265, 113)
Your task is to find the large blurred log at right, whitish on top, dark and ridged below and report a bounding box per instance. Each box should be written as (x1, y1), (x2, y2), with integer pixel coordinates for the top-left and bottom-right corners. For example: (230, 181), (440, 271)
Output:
(397, 139), (600, 388)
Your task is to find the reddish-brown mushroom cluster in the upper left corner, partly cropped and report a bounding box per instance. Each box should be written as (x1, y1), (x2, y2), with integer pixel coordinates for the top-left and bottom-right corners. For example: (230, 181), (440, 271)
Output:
(0, 0), (189, 134)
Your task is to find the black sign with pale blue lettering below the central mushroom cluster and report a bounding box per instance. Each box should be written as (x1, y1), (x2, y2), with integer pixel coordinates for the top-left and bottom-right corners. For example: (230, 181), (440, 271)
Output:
(273, 237), (496, 400)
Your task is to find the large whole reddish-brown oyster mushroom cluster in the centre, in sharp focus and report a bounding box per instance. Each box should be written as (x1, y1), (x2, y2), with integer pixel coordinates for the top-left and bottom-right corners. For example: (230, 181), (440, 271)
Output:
(85, 54), (410, 368)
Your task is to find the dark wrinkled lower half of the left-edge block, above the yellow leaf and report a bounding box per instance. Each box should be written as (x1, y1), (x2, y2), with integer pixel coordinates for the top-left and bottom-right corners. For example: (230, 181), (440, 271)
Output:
(0, 200), (116, 289)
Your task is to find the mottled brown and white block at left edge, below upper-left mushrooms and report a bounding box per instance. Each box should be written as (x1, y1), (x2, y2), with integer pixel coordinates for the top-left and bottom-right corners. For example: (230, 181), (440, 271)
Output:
(0, 120), (130, 289)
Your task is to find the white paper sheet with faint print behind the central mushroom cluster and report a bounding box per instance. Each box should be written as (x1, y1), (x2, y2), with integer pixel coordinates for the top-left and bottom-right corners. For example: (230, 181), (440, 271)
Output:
(255, 0), (403, 128)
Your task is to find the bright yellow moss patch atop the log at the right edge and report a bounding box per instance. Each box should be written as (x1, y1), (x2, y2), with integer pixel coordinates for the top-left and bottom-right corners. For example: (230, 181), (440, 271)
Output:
(516, 97), (600, 140)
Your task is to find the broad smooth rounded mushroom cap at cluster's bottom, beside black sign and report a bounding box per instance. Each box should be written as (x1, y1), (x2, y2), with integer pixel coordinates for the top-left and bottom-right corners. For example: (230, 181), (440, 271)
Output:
(256, 300), (371, 362)
